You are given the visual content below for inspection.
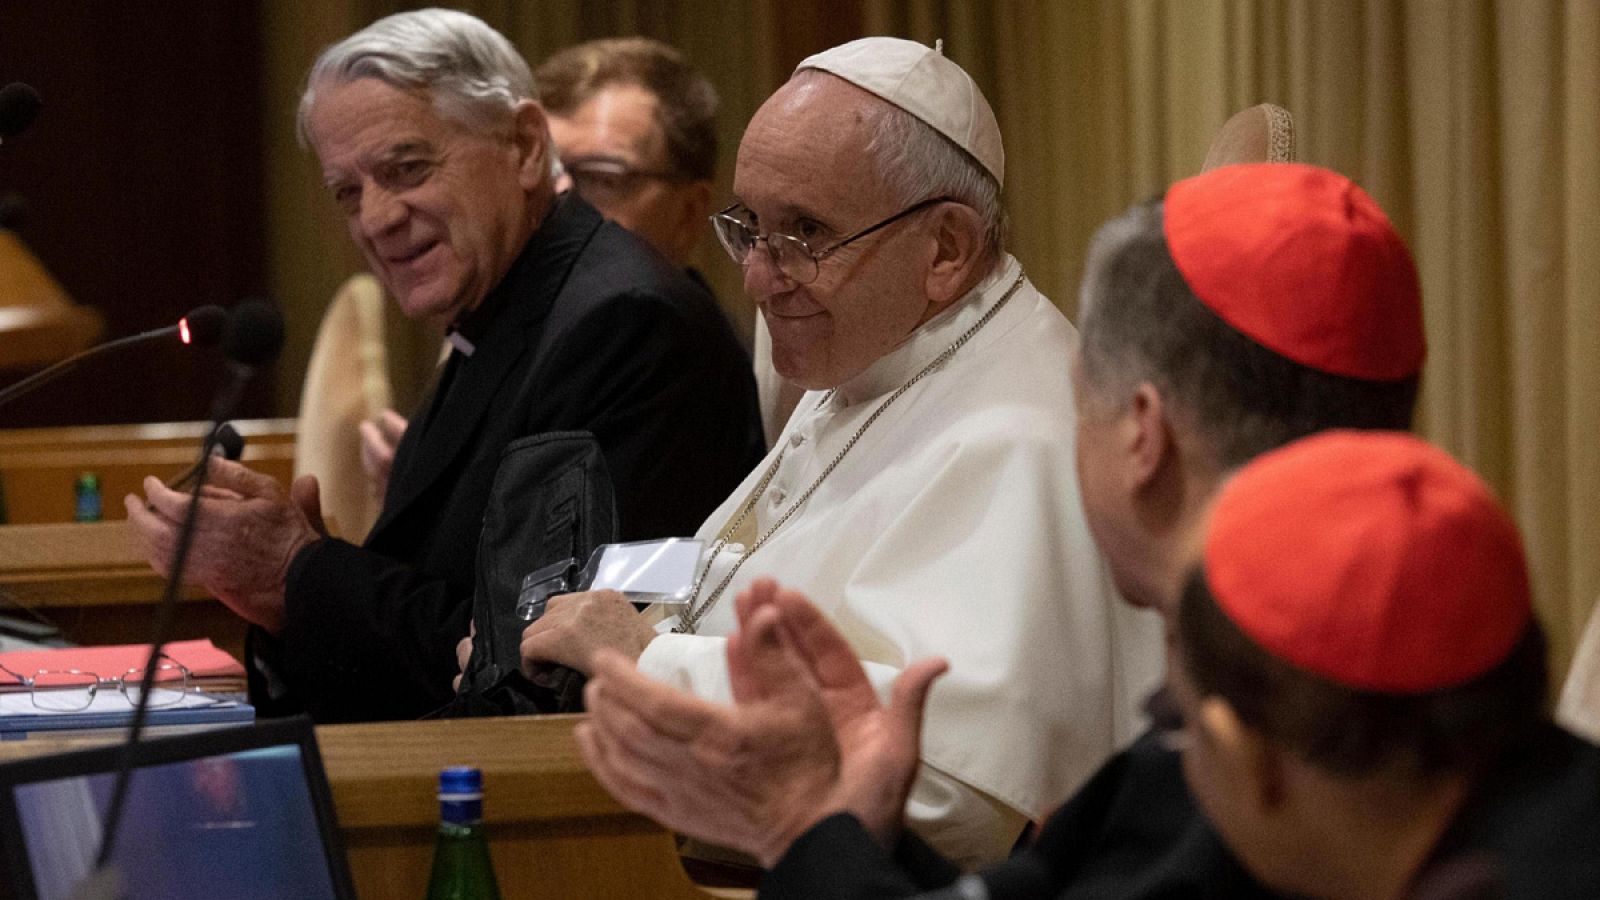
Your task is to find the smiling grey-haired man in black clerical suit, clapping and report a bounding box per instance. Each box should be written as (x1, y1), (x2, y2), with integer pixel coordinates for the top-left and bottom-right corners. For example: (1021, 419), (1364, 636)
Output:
(126, 10), (762, 722)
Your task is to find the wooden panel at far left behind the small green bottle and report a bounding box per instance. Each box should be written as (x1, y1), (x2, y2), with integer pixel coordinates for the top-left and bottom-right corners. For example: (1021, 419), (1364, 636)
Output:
(0, 420), (294, 522)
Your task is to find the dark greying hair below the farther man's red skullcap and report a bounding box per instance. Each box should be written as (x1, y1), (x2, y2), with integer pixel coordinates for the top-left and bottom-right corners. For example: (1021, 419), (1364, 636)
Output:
(1080, 200), (1418, 468)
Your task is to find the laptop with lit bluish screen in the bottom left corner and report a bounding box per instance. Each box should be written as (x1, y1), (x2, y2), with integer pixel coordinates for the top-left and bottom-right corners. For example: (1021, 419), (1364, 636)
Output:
(0, 719), (355, 900)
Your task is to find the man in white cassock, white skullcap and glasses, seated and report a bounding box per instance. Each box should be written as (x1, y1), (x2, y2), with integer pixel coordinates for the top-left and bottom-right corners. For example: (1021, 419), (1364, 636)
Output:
(522, 38), (1160, 865)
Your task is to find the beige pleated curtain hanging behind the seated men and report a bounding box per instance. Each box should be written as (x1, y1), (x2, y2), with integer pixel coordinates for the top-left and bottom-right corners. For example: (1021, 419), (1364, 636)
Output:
(267, 0), (1600, 671)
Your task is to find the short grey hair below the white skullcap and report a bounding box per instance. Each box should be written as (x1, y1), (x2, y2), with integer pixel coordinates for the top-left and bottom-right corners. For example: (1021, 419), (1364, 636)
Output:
(867, 85), (1006, 266)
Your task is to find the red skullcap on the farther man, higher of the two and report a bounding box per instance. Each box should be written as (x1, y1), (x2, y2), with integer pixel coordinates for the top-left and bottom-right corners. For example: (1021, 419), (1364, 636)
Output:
(1163, 163), (1427, 381)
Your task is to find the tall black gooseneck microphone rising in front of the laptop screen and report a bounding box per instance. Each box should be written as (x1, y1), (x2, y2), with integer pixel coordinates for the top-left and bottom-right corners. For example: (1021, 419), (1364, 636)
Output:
(94, 299), (283, 878)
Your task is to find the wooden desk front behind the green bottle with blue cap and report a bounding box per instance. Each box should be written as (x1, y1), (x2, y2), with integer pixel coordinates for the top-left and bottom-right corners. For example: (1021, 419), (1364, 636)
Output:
(0, 716), (750, 900)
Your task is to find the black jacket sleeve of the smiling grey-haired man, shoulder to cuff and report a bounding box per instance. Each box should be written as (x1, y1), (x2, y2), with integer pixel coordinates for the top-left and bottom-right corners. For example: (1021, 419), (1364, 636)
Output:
(253, 280), (760, 722)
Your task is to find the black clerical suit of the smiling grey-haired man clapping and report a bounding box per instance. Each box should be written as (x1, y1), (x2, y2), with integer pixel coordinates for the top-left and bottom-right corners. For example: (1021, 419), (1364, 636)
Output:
(251, 192), (763, 722)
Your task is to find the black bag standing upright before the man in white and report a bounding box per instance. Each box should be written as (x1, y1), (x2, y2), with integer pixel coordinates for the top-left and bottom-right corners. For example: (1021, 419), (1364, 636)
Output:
(435, 431), (616, 717)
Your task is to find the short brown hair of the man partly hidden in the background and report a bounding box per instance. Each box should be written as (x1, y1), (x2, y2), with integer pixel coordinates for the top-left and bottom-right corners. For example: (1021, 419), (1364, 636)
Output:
(533, 37), (717, 181)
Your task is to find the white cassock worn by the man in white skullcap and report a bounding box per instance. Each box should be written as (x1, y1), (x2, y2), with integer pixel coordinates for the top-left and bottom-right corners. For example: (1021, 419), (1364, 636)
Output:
(638, 256), (1163, 866)
